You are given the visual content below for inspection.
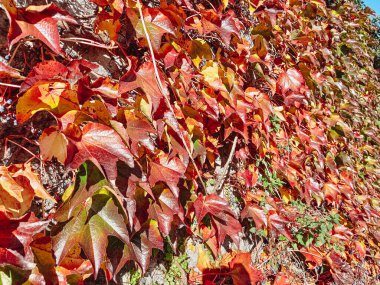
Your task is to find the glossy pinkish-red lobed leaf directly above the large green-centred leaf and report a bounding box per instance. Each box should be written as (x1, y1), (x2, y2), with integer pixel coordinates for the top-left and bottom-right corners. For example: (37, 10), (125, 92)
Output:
(70, 122), (134, 181)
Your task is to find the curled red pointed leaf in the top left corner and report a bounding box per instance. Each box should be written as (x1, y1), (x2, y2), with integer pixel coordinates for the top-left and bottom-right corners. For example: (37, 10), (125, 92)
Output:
(2, 0), (76, 54)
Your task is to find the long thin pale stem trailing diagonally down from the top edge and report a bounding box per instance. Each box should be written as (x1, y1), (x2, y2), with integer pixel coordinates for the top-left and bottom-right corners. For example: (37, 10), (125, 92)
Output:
(136, 0), (206, 190)
